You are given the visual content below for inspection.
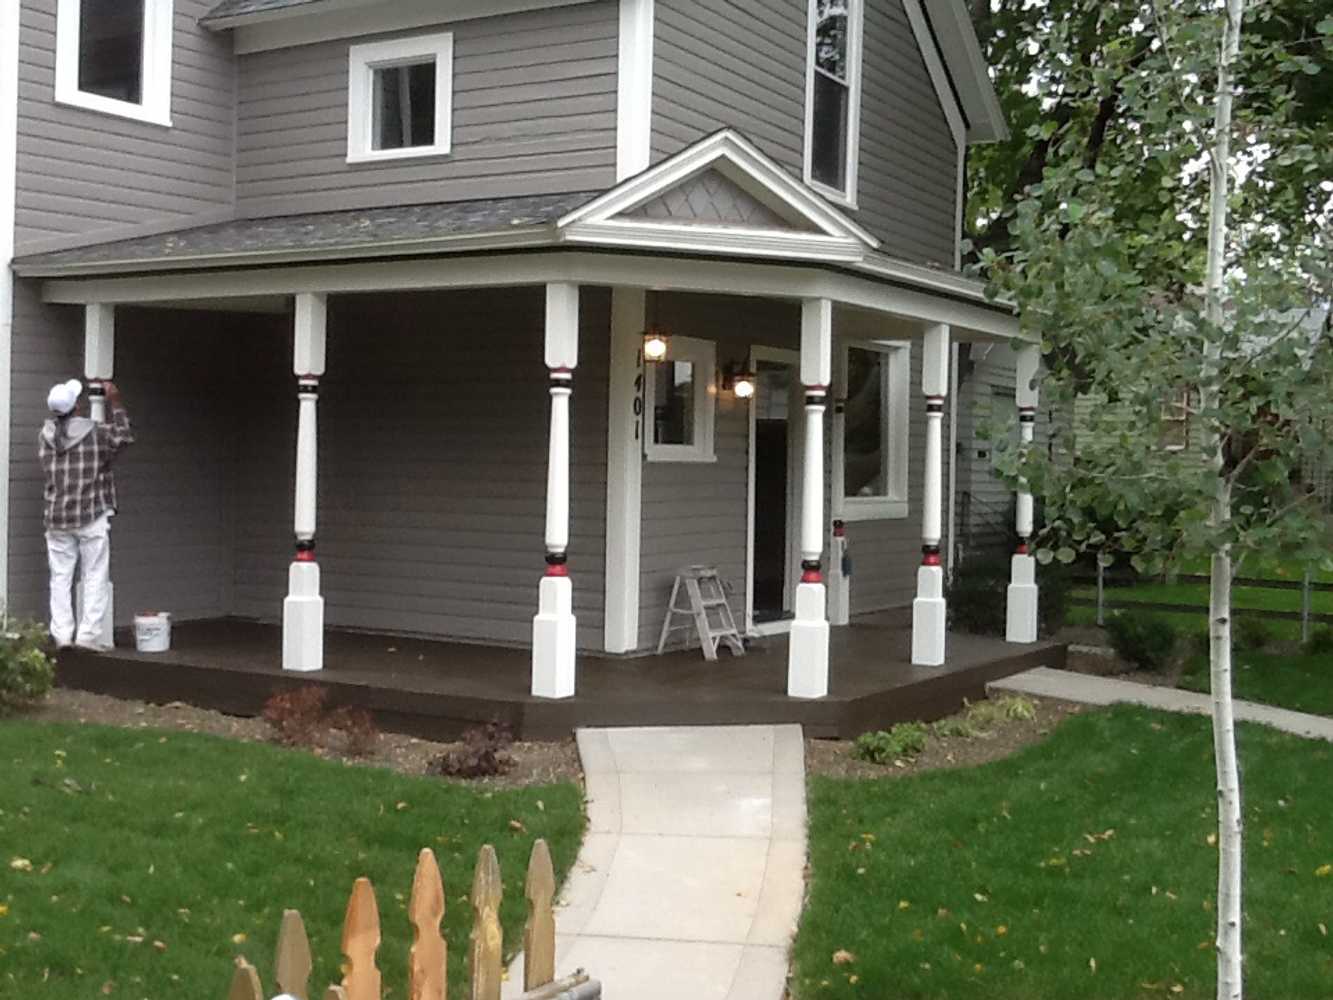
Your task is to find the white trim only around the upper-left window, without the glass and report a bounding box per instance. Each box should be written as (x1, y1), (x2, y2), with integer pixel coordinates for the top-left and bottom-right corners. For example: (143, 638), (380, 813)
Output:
(56, 0), (173, 127)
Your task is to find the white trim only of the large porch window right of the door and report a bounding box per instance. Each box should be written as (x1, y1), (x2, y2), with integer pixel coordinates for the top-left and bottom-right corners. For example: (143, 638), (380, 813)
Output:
(832, 340), (912, 521)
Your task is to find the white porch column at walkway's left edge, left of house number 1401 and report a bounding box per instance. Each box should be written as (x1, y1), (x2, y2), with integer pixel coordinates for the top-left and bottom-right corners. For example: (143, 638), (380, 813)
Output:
(532, 283), (579, 697)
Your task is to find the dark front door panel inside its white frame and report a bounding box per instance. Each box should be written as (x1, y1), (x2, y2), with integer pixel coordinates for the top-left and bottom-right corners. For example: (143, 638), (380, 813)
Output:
(753, 361), (792, 623)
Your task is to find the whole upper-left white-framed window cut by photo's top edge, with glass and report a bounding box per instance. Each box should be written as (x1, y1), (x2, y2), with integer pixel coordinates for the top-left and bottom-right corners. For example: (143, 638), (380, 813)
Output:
(56, 0), (172, 125)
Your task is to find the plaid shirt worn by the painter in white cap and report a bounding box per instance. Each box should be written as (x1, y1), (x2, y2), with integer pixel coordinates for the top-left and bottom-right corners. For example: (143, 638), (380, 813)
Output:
(37, 407), (135, 531)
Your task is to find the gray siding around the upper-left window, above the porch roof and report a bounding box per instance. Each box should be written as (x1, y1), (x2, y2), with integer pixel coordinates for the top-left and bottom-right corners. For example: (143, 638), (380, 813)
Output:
(11, 0), (236, 253)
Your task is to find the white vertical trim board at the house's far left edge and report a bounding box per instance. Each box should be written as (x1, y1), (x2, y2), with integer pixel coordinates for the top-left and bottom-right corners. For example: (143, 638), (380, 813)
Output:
(0, 0), (20, 621)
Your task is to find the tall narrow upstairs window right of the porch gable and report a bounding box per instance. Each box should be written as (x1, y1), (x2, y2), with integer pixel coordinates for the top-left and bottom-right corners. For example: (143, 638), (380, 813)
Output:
(805, 0), (864, 208)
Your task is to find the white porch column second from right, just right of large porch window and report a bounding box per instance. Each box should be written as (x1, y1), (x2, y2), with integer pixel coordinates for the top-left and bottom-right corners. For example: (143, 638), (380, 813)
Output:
(912, 323), (949, 667)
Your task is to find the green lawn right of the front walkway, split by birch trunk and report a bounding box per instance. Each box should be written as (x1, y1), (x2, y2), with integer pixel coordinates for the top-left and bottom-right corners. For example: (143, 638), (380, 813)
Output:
(792, 708), (1333, 1000)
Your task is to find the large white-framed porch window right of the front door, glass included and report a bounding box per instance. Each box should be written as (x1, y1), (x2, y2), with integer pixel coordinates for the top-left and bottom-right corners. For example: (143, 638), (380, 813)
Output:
(833, 341), (912, 521)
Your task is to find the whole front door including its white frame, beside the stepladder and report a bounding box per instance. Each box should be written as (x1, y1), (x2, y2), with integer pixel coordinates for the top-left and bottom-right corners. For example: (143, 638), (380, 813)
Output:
(750, 348), (802, 631)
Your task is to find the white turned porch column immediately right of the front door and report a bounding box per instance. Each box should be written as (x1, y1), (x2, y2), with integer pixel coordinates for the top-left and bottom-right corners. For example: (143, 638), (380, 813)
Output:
(786, 299), (833, 697)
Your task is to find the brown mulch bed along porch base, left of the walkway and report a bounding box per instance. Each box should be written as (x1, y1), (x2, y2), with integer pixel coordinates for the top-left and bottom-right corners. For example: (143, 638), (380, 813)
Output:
(21, 688), (583, 788)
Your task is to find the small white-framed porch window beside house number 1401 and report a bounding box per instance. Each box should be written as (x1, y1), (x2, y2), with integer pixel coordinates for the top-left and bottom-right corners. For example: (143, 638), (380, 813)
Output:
(644, 336), (717, 461)
